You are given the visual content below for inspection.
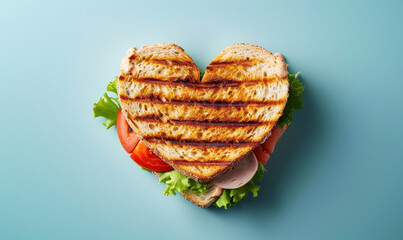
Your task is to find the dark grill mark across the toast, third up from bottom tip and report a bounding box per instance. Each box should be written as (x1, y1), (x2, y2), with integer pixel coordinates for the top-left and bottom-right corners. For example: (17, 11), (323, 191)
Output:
(130, 115), (277, 127)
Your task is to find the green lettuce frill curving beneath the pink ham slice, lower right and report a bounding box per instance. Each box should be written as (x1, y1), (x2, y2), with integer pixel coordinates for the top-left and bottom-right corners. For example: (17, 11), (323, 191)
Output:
(214, 163), (265, 209)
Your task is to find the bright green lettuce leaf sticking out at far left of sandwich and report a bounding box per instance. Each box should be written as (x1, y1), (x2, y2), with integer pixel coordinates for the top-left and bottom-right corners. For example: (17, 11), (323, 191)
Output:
(92, 77), (120, 129)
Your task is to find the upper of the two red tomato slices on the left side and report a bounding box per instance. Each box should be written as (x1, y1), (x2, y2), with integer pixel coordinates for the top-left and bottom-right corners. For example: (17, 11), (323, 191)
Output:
(116, 109), (140, 153)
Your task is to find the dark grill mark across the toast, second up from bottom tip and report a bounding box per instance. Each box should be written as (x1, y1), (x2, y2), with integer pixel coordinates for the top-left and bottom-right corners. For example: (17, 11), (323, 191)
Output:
(143, 136), (258, 148)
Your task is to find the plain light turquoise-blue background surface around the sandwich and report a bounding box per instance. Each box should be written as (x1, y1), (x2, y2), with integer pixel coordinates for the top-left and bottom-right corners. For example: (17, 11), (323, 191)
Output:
(0, 1), (403, 239)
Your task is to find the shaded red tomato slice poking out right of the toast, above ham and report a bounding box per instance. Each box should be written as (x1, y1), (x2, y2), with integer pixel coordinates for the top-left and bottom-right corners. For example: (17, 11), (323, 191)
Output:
(253, 126), (287, 164)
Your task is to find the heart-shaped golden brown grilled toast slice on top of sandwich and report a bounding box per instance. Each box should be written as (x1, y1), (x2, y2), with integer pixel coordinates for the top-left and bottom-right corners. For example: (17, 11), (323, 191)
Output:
(118, 43), (288, 182)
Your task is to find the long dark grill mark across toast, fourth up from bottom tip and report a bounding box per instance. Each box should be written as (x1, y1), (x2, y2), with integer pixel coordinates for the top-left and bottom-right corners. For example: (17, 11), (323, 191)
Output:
(119, 95), (287, 107)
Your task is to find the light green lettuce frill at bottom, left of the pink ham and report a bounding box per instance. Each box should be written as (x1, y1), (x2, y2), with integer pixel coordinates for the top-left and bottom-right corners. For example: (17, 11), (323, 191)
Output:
(156, 170), (207, 195)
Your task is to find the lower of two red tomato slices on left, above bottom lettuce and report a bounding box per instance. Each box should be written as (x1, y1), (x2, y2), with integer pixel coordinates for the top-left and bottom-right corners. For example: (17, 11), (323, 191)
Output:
(130, 142), (173, 172)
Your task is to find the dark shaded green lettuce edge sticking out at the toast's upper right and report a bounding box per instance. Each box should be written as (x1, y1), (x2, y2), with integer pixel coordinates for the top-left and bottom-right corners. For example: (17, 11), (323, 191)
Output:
(277, 72), (305, 127)
